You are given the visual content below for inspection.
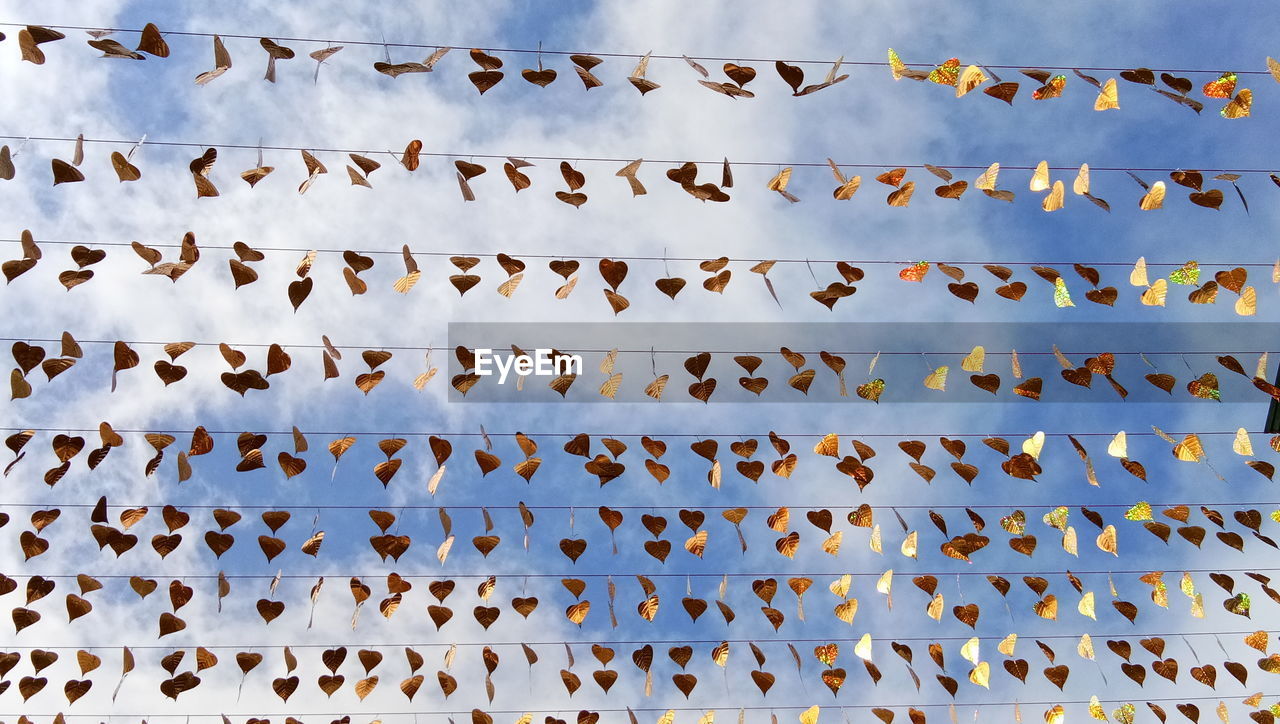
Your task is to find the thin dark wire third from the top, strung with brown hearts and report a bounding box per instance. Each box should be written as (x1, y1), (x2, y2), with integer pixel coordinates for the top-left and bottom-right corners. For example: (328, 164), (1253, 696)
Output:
(0, 238), (1274, 269)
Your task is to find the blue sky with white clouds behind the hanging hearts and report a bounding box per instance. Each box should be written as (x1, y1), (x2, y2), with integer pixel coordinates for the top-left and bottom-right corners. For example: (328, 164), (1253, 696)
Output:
(0, 3), (1280, 721)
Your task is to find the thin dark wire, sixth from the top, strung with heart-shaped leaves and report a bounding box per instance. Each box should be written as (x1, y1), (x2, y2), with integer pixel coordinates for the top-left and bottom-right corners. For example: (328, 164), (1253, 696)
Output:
(0, 501), (1280, 510)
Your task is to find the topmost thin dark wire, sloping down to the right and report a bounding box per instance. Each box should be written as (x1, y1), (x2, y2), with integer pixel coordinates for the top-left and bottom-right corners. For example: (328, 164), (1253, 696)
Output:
(0, 22), (1270, 75)
